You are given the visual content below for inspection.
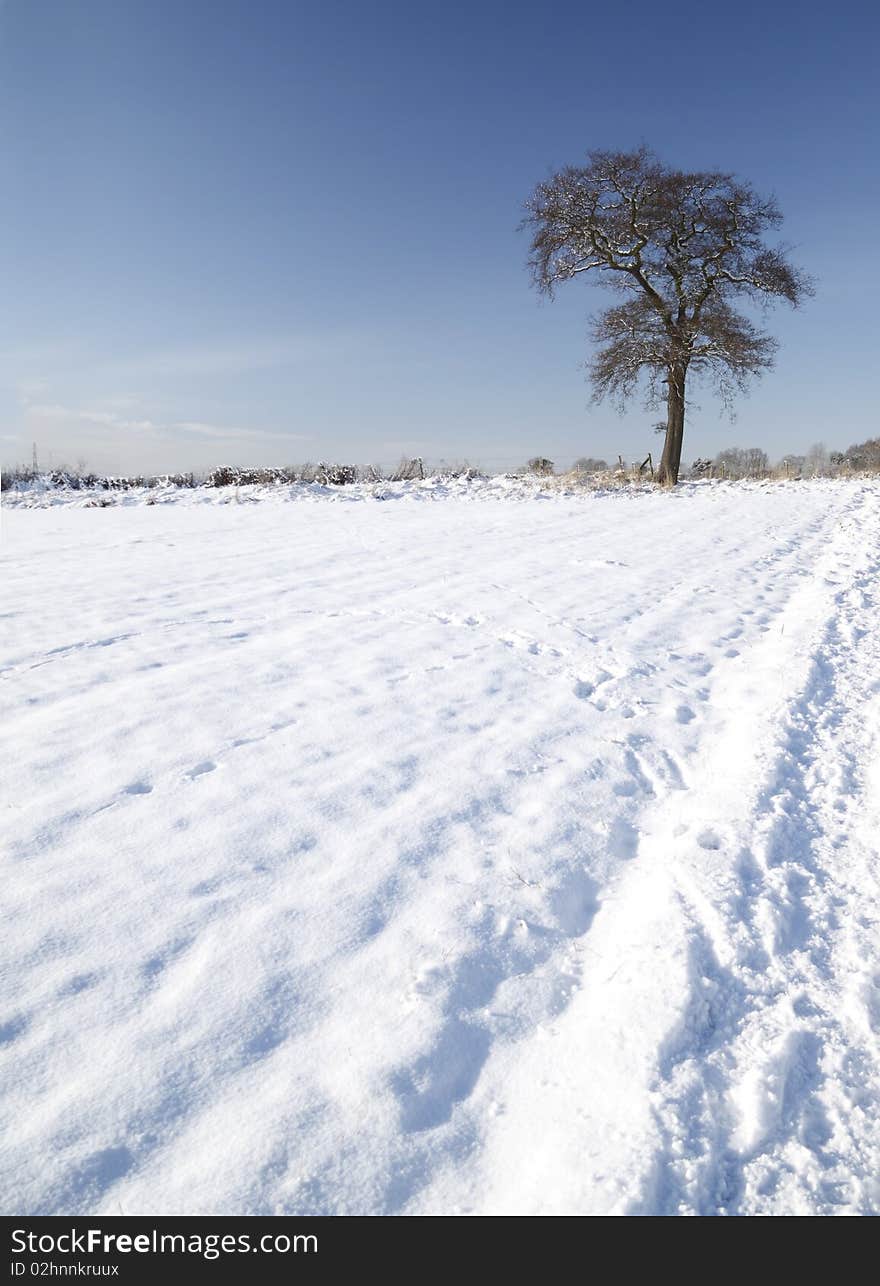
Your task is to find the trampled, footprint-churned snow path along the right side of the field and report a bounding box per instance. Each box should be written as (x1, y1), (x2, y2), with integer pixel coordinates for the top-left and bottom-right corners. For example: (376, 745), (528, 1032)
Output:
(633, 483), (880, 1214)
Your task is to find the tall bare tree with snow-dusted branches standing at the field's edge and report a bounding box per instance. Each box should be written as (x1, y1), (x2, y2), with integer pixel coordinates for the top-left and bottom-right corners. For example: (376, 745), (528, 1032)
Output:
(524, 148), (812, 482)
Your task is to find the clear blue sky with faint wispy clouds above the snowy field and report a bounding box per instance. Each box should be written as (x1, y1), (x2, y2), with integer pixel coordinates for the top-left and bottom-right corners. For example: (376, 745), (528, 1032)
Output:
(0, 0), (880, 472)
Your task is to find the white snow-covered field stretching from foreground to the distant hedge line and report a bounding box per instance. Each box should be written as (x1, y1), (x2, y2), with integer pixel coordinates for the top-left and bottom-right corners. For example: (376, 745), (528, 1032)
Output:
(0, 482), (880, 1214)
